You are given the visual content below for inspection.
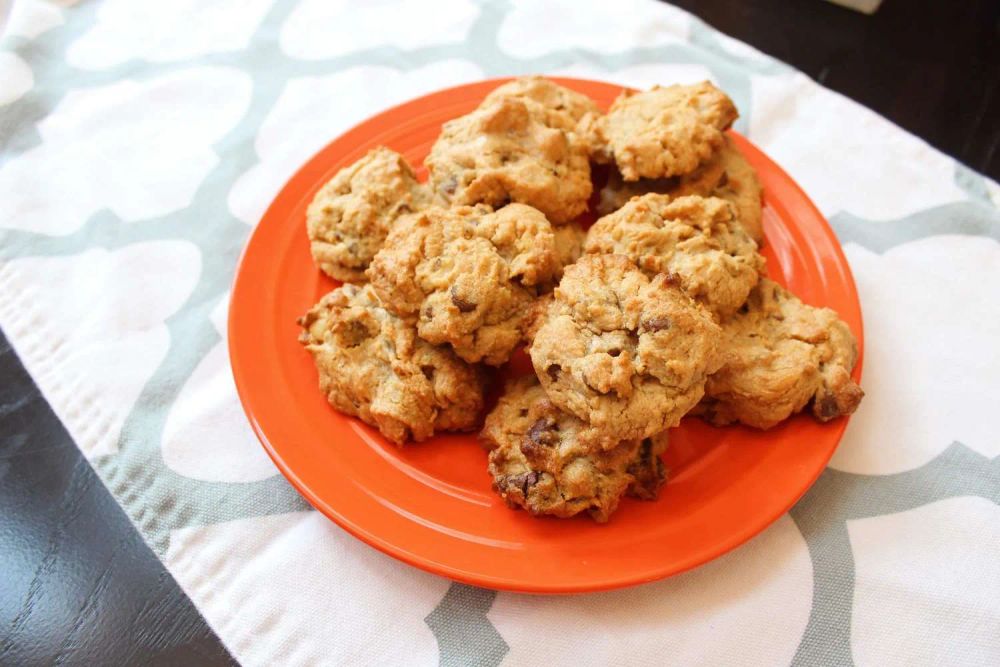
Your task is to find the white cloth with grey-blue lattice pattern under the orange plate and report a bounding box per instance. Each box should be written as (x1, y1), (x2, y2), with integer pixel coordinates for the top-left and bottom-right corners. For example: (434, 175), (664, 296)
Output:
(0, 0), (1000, 666)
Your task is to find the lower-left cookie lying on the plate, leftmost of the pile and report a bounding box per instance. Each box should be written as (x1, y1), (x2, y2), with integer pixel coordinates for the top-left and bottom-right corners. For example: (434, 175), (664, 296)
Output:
(299, 284), (483, 444)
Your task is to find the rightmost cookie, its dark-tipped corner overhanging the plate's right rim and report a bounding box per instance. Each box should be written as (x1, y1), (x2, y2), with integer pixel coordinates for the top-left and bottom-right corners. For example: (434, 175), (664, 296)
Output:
(697, 278), (864, 429)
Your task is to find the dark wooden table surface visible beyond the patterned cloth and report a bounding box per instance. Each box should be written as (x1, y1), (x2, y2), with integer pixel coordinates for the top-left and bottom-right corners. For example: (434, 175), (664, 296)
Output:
(0, 0), (1000, 665)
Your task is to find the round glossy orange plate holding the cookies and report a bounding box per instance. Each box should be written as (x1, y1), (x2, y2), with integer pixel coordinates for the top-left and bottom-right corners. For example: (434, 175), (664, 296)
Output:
(229, 79), (862, 593)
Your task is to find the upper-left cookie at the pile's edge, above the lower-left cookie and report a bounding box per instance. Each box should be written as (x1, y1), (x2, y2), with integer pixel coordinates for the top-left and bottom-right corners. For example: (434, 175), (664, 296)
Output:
(306, 147), (430, 283)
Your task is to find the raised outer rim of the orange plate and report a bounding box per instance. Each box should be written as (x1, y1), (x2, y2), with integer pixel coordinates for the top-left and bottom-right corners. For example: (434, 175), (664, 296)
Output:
(226, 76), (864, 595)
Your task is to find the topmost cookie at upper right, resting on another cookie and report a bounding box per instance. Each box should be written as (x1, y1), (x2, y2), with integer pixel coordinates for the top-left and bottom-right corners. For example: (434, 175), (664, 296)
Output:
(586, 81), (739, 181)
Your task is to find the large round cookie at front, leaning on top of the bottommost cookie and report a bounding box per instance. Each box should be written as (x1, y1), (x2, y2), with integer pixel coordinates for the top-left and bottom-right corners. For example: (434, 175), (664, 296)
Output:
(529, 255), (721, 441)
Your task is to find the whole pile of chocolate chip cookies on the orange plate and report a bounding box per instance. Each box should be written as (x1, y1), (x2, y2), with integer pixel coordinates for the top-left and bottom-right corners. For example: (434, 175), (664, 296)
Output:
(300, 77), (863, 521)
